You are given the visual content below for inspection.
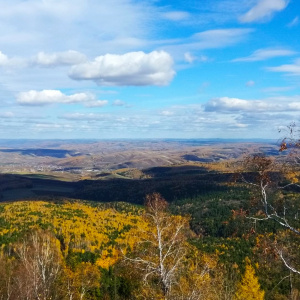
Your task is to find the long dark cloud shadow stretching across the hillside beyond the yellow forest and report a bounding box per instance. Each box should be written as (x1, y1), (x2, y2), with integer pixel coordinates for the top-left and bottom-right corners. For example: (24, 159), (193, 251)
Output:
(0, 166), (231, 204)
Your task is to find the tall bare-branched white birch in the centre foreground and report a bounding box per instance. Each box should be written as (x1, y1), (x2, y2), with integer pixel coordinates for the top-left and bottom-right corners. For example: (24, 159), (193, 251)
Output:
(125, 193), (216, 300)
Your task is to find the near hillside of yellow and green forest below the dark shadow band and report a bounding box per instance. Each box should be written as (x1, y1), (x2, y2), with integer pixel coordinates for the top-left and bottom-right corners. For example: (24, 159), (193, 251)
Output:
(0, 182), (299, 299)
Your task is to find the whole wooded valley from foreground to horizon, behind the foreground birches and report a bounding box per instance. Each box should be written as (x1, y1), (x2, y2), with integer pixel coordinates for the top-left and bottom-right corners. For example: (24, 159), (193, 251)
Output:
(0, 140), (300, 300)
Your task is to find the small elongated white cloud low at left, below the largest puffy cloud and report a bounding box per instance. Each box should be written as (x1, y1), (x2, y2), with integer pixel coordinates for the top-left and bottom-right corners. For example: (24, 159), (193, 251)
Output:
(17, 90), (95, 106)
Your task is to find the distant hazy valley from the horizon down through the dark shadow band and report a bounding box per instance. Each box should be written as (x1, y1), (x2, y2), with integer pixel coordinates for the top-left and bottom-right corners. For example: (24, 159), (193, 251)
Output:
(0, 140), (280, 203)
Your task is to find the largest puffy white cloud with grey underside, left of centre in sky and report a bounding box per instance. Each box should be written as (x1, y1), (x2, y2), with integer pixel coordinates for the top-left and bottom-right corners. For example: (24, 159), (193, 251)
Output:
(69, 51), (175, 86)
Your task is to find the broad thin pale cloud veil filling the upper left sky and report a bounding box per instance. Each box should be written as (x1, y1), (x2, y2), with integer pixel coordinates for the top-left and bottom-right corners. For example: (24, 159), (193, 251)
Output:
(0, 0), (158, 56)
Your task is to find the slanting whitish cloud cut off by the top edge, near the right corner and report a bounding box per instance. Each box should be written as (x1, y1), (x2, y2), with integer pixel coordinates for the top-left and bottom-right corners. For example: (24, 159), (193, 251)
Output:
(239, 0), (289, 23)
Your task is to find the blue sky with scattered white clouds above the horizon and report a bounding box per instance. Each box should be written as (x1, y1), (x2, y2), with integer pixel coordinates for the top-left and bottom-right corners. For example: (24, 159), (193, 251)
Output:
(0, 0), (300, 139)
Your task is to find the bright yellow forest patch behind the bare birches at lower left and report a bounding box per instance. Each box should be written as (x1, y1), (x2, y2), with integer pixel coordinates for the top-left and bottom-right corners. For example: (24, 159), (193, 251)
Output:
(0, 201), (147, 268)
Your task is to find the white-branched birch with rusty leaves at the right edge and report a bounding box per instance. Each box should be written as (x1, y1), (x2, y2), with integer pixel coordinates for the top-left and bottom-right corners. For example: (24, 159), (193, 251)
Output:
(240, 155), (300, 275)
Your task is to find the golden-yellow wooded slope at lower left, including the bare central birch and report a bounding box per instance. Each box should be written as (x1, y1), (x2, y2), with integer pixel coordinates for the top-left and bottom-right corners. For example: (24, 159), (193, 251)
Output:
(0, 198), (222, 300)
